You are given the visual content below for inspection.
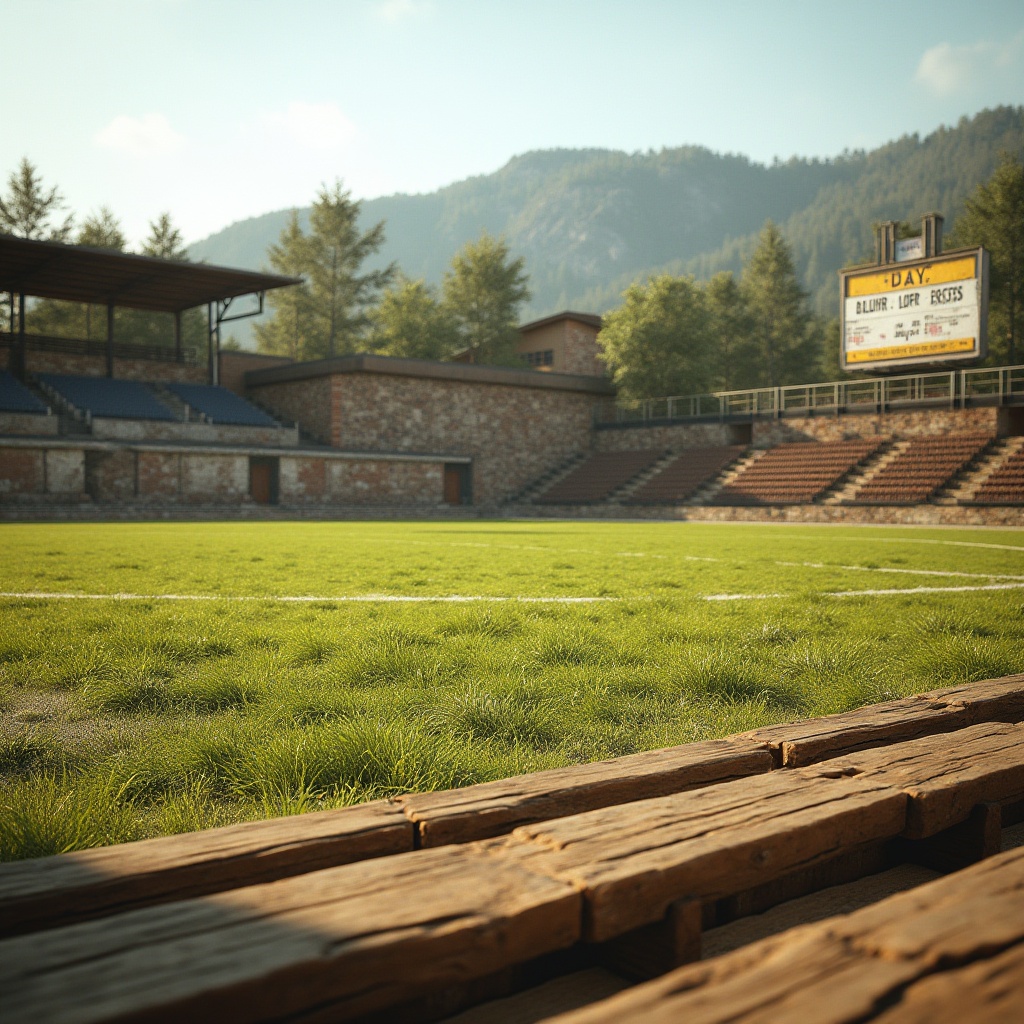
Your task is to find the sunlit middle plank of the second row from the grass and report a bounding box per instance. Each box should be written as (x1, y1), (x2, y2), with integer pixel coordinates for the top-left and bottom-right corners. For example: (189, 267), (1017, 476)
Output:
(481, 769), (906, 942)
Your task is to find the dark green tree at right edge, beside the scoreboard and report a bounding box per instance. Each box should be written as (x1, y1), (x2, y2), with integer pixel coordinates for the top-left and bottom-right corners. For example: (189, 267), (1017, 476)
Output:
(951, 154), (1024, 364)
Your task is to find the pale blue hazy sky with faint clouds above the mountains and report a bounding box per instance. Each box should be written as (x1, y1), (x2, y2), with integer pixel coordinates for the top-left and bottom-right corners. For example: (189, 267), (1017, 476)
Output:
(0, 0), (1024, 245)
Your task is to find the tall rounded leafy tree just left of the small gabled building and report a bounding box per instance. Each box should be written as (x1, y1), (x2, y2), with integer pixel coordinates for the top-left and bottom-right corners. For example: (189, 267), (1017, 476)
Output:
(443, 231), (529, 366)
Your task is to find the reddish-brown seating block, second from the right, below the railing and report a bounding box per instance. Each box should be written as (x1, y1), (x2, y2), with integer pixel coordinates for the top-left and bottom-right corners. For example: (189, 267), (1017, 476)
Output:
(853, 434), (994, 505)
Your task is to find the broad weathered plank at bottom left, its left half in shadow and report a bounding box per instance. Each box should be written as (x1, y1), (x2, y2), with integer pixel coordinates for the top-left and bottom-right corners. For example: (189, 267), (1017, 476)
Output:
(0, 846), (581, 1022)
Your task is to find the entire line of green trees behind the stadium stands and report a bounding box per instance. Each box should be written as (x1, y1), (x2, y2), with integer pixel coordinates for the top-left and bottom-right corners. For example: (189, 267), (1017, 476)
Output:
(0, 154), (1024, 398)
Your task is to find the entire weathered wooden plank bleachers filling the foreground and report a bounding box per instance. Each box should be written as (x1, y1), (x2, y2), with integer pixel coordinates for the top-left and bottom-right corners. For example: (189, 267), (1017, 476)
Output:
(0, 675), (1024, 1024)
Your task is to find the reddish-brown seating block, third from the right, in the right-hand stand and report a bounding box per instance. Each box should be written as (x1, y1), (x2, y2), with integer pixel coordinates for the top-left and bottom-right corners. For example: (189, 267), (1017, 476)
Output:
(713, 438), (882, 505)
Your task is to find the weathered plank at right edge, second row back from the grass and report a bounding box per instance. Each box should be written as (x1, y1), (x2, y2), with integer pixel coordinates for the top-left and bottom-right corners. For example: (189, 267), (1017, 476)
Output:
(804, 722), (1024, 839)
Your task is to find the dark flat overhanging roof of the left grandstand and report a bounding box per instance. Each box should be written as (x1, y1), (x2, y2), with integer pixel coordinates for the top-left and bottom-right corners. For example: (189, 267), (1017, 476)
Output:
(0, 234), (299, 312)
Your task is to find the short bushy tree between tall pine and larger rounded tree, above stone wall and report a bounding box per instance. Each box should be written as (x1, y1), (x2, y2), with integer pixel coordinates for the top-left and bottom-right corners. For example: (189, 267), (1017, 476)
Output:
(370, 275), (458, 359)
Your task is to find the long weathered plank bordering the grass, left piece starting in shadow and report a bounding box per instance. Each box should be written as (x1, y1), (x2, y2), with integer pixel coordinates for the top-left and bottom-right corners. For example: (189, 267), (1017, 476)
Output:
(0, 801), (413, 937)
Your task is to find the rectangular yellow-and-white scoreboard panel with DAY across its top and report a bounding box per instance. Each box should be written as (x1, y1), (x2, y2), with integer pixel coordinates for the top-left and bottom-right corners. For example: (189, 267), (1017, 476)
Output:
(840, 246), (988, 370)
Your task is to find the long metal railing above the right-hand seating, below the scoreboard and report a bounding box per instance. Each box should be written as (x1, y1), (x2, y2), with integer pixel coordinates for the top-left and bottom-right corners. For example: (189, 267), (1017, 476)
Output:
(594, 366), (1024, 427)
